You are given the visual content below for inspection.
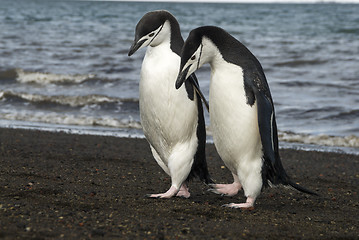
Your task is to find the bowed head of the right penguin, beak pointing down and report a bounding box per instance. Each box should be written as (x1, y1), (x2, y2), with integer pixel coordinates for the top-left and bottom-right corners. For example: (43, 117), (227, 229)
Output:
(176, 27), (219, 89)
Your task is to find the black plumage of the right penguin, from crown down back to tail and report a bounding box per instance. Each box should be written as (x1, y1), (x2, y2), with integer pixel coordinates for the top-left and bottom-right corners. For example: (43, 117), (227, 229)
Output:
(181, 26), (316, 195)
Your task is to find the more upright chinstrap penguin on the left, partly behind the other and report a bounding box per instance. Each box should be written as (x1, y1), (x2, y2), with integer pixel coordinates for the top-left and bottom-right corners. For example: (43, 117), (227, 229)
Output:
(128, 10), (213, 198)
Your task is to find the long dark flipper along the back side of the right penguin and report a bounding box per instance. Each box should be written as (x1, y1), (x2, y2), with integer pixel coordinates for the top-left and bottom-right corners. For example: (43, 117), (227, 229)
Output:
(251, 74), (280, 169)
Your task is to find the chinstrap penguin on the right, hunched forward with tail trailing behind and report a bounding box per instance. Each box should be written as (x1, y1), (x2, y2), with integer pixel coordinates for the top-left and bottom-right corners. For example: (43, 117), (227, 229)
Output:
(176, 26), (317, 209)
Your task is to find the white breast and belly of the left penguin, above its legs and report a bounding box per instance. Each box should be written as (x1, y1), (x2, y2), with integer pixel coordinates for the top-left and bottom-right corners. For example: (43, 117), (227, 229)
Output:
(139, 43), (198, 165)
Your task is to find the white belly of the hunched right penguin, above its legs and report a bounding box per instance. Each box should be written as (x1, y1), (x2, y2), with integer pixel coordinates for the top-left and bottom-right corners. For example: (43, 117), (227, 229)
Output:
(209, 63), (262, 175)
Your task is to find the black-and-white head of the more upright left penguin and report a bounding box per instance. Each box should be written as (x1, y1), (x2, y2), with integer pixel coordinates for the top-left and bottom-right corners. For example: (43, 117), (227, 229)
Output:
(128, 10), (174, 56)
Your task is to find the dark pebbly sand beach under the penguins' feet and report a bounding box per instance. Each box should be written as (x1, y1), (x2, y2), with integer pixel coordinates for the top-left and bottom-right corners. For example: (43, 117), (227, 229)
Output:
(0, 129), (359, 239)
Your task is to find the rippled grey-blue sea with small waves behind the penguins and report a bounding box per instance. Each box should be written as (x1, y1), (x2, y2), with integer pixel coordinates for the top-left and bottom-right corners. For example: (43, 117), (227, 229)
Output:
(0, 0), (359, 153)
